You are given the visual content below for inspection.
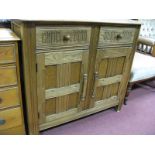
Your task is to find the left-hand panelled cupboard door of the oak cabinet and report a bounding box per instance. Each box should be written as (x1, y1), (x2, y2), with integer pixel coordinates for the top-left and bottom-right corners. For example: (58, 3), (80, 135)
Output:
(37, 50), (89, 124)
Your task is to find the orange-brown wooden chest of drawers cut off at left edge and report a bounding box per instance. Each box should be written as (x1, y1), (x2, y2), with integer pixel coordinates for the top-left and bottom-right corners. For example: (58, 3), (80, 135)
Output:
(0, 28), (25, 135)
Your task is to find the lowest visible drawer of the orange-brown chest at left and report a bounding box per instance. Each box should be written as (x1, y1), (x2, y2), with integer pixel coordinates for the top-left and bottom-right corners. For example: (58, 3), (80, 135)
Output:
(0, 107), (22, 131)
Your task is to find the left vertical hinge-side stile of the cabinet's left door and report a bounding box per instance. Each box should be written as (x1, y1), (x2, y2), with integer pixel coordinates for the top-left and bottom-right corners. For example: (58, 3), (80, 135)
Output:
(37, 54), (46, 124)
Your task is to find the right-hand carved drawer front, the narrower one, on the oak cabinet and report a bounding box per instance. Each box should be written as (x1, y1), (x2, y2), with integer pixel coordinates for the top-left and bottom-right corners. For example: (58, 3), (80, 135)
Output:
(98, 27), (136, 47)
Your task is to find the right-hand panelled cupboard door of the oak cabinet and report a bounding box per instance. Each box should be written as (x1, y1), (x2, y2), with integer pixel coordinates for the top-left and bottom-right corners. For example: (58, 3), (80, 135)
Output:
(92, 47), (133, 108)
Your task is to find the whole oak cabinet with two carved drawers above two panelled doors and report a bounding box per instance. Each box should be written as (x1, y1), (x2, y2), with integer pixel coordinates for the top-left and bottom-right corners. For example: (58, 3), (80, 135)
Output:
(12, 20), (140, 134)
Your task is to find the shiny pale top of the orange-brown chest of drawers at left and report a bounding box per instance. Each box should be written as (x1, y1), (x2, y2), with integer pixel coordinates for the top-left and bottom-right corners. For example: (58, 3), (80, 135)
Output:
(0, 28), (20, 42)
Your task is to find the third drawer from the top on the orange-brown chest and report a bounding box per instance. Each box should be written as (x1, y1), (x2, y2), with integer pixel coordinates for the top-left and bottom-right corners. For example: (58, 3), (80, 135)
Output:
(0, 87), (20, 109)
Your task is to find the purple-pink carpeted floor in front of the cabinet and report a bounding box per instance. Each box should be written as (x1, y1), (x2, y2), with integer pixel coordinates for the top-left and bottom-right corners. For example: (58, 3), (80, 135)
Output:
(41, 81), (155, 135)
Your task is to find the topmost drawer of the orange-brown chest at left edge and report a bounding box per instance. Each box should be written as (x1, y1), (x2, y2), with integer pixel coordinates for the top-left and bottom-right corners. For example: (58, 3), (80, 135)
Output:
(0, 44), (16, 64)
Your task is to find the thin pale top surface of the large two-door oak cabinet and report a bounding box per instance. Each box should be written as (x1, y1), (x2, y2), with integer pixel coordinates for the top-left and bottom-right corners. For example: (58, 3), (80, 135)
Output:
(13, 18), (141, 25)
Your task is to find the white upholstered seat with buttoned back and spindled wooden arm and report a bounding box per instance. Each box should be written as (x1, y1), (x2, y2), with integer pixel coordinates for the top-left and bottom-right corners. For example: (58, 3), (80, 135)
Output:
(125, 19), (155, 103)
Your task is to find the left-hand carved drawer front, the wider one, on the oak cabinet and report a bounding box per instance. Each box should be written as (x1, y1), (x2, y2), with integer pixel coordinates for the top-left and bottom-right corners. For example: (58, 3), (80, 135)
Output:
(36, 27), (91, 49)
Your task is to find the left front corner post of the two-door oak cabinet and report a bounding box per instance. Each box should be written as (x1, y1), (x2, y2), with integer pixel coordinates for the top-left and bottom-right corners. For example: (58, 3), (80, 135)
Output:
(19, 23), (39, 134)
